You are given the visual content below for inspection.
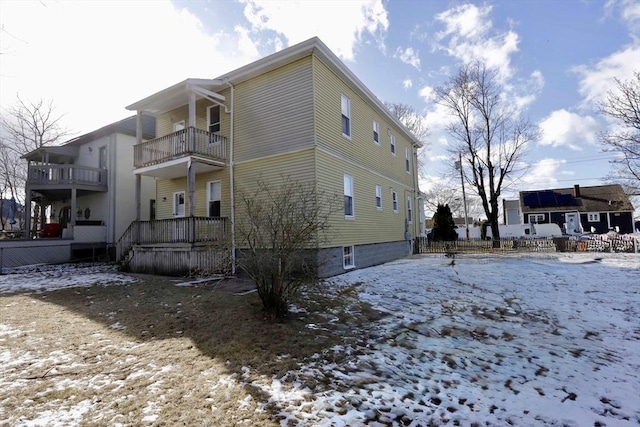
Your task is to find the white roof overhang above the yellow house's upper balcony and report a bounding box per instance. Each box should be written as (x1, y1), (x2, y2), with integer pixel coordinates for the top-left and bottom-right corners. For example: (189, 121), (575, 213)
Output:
(126, 79), (225, 116)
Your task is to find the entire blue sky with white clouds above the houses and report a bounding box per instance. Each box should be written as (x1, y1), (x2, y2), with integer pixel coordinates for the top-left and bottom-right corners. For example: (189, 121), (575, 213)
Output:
(0, 0), (640, 214)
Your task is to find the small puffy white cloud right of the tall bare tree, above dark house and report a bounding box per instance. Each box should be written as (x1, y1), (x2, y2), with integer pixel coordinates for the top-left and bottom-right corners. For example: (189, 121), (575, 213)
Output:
(538, 109), (600, 151)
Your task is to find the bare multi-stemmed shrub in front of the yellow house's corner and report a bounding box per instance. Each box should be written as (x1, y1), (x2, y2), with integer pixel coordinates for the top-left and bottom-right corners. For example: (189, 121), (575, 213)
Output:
(236, 176), (340, 318)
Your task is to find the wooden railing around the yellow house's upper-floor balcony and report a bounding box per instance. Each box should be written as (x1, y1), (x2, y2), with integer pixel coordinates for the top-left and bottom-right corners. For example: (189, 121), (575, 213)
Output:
(133, 127), (227, 168)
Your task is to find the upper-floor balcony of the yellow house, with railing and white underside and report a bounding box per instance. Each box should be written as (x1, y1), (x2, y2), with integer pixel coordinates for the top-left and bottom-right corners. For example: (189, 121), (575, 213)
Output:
(133, 127), (227, 178)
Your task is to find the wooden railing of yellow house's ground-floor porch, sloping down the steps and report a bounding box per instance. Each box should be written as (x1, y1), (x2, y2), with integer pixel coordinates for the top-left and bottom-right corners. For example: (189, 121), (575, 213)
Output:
(116, 217), (227, 261)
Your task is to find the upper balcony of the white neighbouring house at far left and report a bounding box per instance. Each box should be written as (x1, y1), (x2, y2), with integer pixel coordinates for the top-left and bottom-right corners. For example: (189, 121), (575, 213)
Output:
(27, 164), (108, 191)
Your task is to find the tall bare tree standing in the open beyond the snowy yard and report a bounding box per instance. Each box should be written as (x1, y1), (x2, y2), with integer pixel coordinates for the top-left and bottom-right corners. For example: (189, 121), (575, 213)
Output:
(435, 61), (539, 240)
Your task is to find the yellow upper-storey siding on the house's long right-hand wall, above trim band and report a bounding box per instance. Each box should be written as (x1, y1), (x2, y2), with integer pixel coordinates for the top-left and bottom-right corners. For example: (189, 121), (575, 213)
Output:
(313, 57), (413, 186)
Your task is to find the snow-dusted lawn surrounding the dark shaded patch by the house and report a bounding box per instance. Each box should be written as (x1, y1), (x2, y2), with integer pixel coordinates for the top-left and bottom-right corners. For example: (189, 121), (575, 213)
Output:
(0, 252), (640, 427)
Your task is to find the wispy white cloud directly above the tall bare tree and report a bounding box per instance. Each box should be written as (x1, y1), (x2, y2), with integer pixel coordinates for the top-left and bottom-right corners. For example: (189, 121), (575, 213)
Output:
(436, 4), (520, 80)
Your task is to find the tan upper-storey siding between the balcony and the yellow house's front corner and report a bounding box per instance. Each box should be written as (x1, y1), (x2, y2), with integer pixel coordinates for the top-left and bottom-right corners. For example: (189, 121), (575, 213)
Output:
(234, 56), (314, 162)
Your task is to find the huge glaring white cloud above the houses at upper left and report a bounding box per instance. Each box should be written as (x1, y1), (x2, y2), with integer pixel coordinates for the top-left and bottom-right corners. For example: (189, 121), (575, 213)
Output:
(0, 1), (259, 133)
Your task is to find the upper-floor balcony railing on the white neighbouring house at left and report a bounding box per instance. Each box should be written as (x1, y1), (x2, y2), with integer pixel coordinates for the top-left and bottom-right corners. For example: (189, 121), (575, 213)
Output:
(27, 165), (107, 187)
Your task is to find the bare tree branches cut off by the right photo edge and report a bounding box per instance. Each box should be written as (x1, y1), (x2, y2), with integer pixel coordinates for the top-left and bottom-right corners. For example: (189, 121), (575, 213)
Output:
(598, 71), (640, 195)
